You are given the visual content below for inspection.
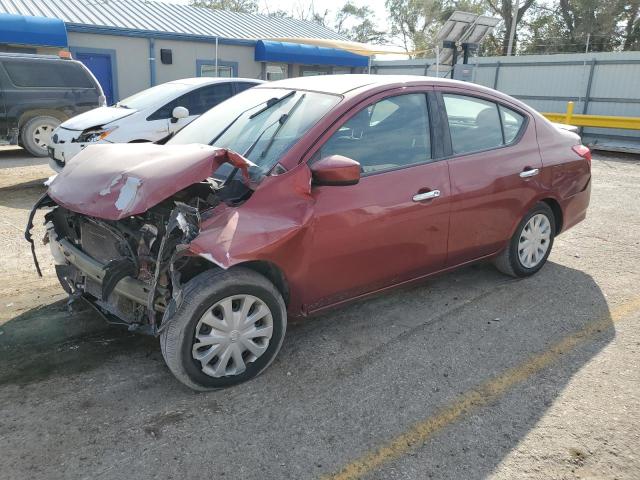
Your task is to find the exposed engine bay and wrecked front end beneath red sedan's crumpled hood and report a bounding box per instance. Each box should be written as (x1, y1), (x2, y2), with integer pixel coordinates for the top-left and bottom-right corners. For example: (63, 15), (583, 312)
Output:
(25, 144), (260, 335)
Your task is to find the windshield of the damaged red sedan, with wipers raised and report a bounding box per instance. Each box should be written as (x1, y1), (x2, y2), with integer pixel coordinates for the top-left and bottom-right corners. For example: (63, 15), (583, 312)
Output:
(167, 88), (340, 177)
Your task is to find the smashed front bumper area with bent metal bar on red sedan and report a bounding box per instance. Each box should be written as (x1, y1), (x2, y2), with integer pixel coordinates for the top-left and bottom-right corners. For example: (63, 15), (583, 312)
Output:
(25, 195), (200, 335)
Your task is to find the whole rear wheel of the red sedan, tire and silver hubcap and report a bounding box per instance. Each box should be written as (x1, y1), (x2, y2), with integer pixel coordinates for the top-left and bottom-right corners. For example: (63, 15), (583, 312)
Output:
(495, 202), (556, 277)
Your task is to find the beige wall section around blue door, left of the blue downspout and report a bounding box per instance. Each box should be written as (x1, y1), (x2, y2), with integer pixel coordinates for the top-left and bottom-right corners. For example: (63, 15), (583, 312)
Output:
(69, 32), (151, 100)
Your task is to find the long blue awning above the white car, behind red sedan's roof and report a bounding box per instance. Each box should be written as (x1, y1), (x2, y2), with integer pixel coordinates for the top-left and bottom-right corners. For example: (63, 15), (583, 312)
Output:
(255, 40), (369, 67)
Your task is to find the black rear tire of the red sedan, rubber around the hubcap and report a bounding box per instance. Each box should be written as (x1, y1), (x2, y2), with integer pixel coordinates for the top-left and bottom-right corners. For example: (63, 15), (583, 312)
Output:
(494, 202), (556, 277)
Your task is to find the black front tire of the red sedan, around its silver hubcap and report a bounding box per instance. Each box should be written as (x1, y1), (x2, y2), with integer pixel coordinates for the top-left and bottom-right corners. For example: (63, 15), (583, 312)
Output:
(160, 267), (287, 391)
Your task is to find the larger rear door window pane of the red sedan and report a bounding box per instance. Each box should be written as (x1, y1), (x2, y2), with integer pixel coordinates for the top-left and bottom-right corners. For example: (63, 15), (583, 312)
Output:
(442, 94), (504, 155)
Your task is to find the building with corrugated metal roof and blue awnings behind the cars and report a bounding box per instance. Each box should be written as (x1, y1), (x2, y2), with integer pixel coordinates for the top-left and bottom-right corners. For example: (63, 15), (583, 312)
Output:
(0, 0), (368, 102)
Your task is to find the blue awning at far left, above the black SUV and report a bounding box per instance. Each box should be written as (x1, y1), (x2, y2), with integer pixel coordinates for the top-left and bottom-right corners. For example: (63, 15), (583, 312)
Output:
(0, 13), (67, 47)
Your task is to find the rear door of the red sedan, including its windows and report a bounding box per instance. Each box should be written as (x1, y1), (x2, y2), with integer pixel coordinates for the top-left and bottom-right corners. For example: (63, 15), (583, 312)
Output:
(438, 89), (542, 266)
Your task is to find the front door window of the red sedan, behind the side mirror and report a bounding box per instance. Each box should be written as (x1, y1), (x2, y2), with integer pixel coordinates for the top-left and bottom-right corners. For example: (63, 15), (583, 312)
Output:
(320, 93), (431, 174)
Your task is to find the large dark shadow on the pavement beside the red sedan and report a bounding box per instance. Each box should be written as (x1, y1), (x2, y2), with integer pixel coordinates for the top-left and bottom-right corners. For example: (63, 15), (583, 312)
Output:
(0, 263), (615, 479)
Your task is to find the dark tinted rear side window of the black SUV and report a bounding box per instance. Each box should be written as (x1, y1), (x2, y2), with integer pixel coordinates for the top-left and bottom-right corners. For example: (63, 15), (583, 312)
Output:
(2, 60), (95, 88)
